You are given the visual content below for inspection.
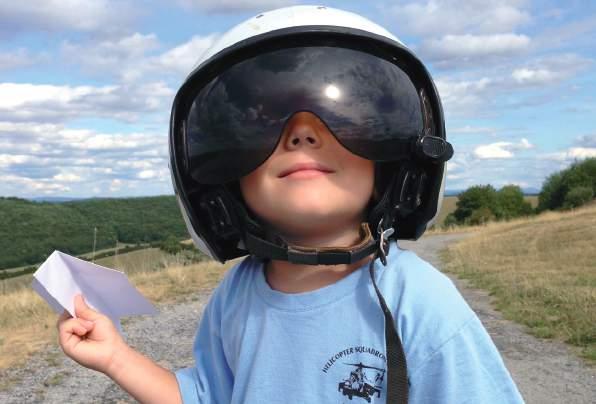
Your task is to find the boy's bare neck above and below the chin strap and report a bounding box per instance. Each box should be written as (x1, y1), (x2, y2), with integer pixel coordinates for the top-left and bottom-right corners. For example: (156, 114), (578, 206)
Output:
(265, 224), (372, 293)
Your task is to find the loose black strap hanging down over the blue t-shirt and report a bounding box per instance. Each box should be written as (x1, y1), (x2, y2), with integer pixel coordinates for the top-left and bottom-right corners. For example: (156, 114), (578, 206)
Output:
(368, 254), (409, 404)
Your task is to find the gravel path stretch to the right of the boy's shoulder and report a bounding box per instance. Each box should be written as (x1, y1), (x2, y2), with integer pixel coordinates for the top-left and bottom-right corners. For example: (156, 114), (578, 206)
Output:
(399, 234), (596, 404)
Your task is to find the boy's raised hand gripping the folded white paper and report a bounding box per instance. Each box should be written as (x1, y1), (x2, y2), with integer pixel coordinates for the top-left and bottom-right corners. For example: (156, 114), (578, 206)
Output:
(57, 295), (126, 373)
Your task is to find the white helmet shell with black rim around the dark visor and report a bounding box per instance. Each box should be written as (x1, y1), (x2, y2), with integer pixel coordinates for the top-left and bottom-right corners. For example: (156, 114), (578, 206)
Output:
(170, 5), (445, 262)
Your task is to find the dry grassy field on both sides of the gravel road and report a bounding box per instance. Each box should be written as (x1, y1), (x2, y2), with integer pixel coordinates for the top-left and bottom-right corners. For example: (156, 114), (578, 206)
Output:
(0, 197), (596, 370)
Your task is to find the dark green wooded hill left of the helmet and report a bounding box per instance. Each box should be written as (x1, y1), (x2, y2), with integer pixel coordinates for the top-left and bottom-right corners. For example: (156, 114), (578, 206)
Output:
(0, 196), (188, 270)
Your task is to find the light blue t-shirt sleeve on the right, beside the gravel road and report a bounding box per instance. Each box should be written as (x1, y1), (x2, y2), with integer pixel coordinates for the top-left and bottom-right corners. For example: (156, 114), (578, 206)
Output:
(410, 315), (524, 404)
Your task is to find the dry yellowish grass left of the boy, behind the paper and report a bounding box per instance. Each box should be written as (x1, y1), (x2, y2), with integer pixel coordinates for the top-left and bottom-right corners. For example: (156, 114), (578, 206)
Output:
(0, 251), (234, 369)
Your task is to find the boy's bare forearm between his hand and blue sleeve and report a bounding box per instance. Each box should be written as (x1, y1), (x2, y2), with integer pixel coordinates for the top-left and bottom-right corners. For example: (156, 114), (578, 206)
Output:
(105, 344), (182, 404)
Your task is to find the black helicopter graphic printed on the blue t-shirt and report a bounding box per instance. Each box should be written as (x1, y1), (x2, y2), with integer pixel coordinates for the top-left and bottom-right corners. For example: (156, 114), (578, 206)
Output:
(337, 362), (385, 403)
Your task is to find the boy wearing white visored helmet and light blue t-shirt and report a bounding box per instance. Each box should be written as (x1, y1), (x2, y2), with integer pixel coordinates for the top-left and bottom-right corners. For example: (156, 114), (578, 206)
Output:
(59, 6), (522, 403)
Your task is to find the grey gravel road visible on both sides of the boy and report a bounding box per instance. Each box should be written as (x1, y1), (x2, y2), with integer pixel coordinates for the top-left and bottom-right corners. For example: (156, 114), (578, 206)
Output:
(0, 235), (596, 404)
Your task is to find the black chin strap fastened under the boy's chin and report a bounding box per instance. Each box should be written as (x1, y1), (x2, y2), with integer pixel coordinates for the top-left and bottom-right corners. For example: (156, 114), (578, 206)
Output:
(244, 223), (377, 265)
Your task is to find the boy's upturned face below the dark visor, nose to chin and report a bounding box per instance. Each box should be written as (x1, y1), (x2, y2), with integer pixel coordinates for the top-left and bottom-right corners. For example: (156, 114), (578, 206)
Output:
(240, 112), (374, 241)
